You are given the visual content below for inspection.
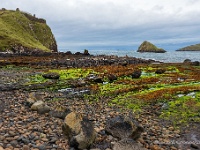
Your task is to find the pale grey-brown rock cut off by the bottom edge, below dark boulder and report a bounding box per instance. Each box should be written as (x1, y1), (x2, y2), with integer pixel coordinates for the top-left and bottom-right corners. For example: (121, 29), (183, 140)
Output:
(113, 139), (147, 150)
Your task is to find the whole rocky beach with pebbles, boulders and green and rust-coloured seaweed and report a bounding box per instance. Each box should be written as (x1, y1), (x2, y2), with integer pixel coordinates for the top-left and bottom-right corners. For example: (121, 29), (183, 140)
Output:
(0, 52), (200, 150)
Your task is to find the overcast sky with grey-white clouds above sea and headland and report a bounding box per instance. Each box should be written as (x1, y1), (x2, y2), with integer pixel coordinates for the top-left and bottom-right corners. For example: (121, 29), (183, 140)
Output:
(0, 0), (200, 51)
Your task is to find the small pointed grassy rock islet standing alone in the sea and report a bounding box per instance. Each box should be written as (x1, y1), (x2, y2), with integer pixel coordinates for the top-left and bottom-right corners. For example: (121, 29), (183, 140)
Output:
(137, 41), (166, 53)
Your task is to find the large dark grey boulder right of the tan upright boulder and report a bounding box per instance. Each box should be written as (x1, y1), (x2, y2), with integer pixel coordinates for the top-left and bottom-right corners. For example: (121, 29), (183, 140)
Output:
(105, 115), (144, 140)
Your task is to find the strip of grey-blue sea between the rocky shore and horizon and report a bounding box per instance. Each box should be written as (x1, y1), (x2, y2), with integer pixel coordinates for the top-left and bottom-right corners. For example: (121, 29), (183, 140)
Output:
(61, 50), (200, 63)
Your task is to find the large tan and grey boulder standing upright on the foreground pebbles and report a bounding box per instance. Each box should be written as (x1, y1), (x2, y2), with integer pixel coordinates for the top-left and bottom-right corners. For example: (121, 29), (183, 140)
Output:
(63, 112), (96, 149)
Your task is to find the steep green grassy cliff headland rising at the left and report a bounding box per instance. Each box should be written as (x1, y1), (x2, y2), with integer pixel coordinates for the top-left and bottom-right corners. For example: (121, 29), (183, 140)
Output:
(0, 9), (57, 52)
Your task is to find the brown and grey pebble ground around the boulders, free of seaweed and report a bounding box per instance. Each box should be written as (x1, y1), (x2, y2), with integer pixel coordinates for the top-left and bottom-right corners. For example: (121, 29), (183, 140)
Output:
(0, 53), (200, 150)
